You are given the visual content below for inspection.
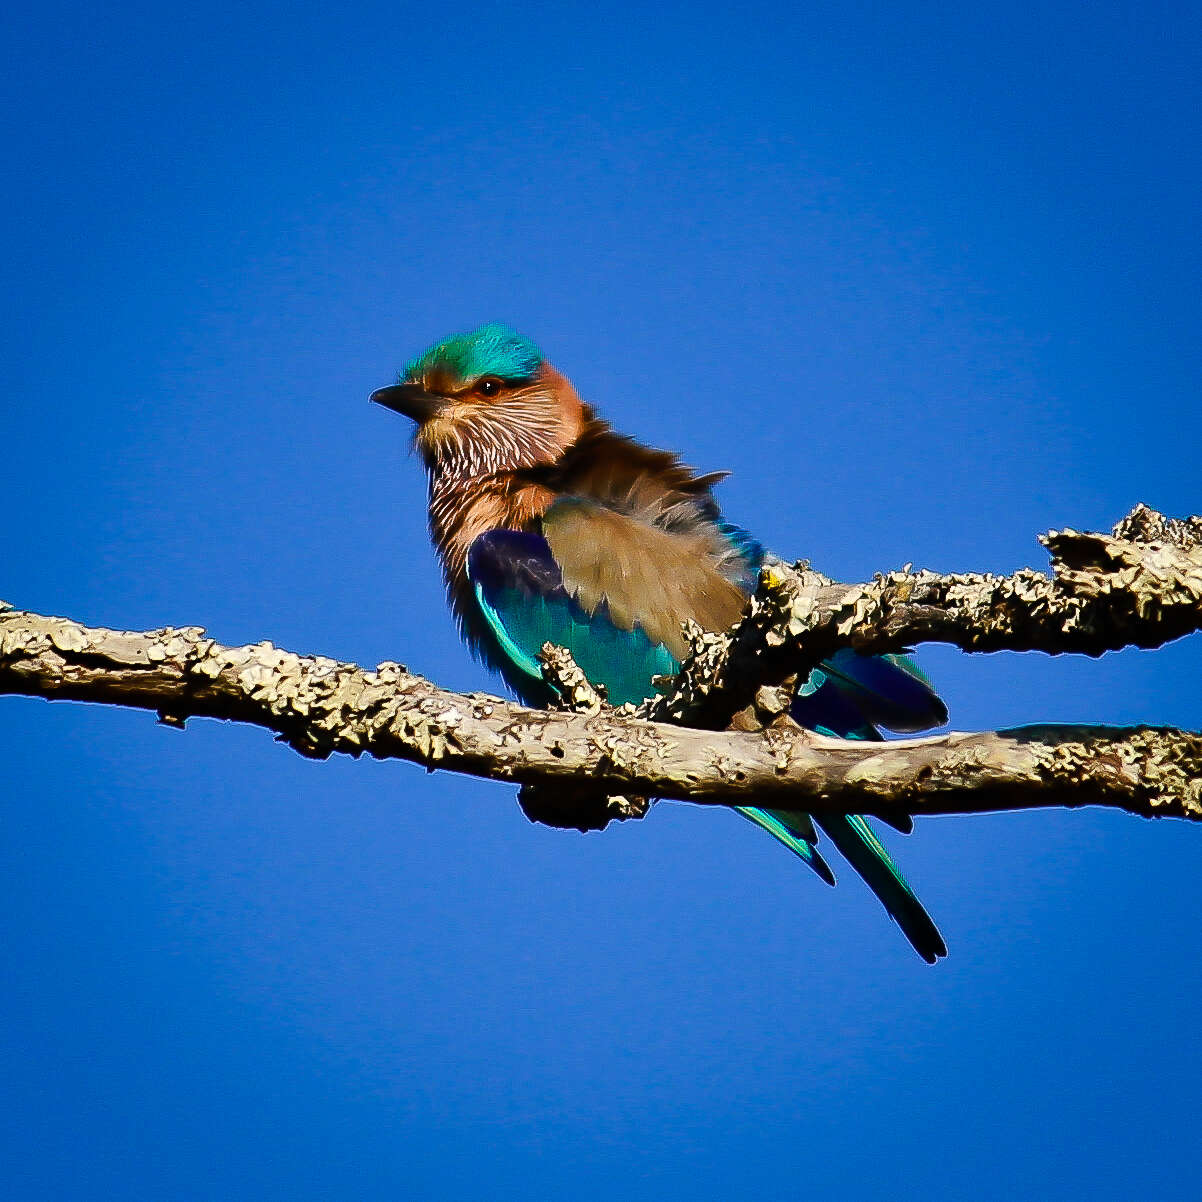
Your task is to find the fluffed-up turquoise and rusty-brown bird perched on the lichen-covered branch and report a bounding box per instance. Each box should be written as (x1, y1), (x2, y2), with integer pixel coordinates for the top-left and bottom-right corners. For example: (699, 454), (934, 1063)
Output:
(370, 322), (947, 964)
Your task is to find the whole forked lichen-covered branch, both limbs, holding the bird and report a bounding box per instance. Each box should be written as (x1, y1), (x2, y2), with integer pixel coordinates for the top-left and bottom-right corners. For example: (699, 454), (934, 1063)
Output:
(0, 507), (1202, 827)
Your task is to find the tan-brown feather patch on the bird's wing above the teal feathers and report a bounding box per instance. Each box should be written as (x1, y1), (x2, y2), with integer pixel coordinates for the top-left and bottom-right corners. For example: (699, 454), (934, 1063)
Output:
(542, 498), (746, 659)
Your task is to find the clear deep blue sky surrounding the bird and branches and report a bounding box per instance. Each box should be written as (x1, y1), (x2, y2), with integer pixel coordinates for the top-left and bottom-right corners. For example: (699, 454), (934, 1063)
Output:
(0, 4), (1202, 1202)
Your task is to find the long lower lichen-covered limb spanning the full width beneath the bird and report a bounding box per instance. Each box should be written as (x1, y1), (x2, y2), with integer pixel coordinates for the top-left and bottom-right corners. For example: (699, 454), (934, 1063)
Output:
(0, 609), (1202, 820)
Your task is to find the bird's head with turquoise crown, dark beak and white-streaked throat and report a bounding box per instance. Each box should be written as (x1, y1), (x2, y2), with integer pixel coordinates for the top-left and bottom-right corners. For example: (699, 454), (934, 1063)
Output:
(371, 322), (584, 476)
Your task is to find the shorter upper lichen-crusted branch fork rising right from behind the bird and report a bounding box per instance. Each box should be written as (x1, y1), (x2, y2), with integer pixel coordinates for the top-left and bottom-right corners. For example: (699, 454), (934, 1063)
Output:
(641, 505), (1202, 730)
